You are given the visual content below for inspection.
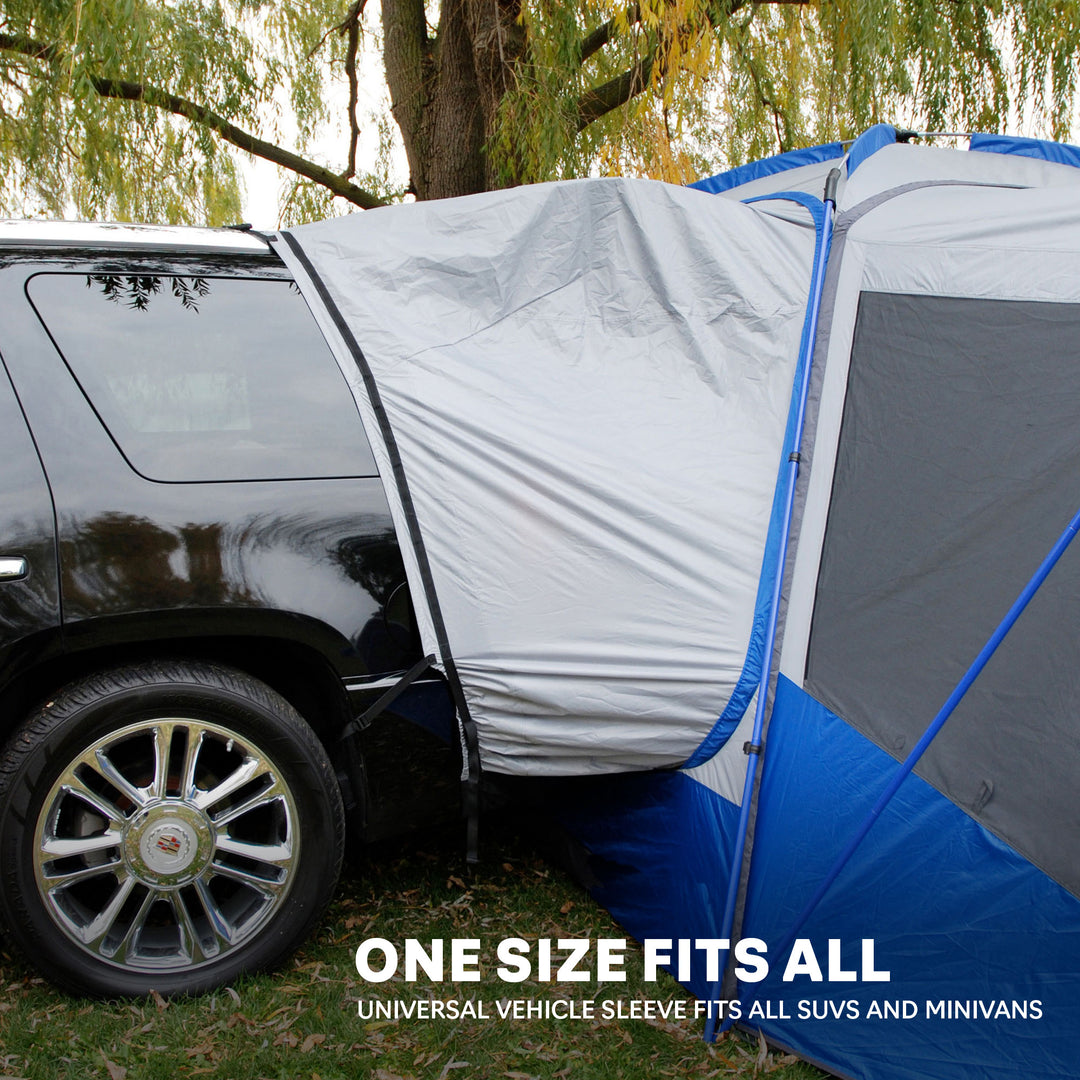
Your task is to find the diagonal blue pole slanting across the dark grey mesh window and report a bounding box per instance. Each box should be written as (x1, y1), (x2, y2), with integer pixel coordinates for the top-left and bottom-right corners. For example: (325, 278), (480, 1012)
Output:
(777, 498), (1080, 955)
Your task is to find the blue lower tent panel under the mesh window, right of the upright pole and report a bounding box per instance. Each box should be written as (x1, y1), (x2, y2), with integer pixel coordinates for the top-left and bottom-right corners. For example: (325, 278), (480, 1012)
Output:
(743, 678), (1080, 1080)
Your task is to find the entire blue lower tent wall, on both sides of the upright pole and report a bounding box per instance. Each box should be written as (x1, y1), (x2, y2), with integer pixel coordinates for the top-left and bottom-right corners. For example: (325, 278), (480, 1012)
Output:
(557, 677), (1080, 1080)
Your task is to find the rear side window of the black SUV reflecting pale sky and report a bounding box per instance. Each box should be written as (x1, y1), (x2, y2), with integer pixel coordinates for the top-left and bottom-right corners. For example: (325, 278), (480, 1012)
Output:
(27, 273), (376, 482)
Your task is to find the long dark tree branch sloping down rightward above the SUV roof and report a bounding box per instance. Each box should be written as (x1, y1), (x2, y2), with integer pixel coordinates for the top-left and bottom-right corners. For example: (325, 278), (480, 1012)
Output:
(0, 33), (386, 210)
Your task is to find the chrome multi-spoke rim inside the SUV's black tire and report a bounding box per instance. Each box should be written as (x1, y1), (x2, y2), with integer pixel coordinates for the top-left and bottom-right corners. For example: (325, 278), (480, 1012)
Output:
(33, 717), (299, 972)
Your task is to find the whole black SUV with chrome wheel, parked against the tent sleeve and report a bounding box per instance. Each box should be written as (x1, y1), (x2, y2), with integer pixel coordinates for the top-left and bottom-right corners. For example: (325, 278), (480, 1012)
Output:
(0, 222), (458, 995)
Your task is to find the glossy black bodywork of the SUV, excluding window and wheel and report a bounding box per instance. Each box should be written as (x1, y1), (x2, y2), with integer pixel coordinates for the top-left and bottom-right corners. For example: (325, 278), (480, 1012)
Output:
(0, 234), (458, 839)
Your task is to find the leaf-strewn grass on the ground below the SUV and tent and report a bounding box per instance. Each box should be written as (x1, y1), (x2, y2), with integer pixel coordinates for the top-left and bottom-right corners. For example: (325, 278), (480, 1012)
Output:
(0, 838), (822, 1080)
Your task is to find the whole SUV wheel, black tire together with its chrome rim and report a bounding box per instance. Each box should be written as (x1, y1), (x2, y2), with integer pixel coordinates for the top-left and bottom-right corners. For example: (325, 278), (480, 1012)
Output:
(0, 661), (345, 997)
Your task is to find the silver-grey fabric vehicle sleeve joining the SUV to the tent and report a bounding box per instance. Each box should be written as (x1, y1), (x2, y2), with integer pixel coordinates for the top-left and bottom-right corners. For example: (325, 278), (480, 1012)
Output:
(278, 179), (814, 774)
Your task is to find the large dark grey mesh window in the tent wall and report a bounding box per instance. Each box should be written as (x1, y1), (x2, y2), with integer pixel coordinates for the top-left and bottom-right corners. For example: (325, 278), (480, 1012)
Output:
(806, 293), (1080, 894)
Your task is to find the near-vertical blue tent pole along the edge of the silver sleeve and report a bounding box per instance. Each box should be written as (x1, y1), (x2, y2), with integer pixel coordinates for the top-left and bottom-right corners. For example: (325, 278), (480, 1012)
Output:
(703, 168), (840, 1042)
